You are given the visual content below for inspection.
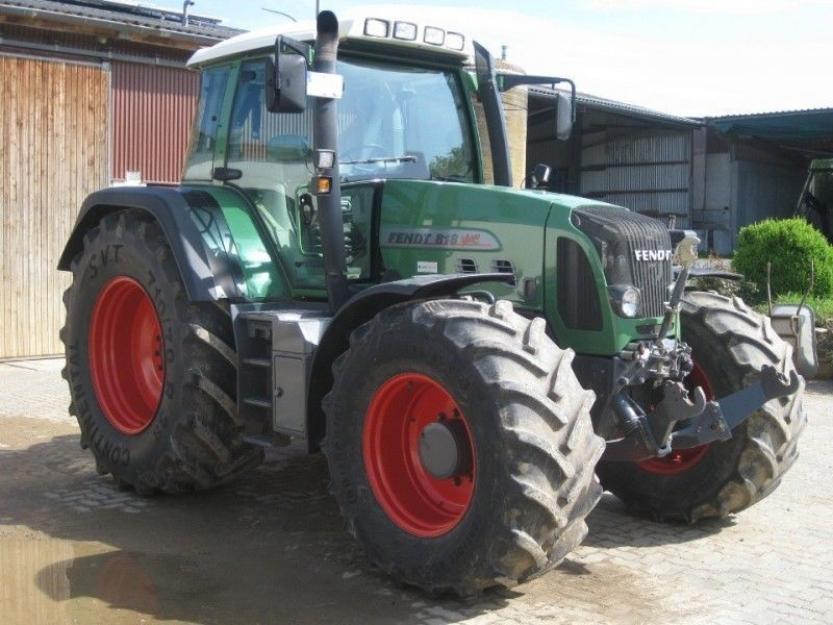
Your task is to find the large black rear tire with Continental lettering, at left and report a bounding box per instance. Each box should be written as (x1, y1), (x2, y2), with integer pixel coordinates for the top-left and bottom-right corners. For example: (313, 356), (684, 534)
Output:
(61, 210), (263, 495)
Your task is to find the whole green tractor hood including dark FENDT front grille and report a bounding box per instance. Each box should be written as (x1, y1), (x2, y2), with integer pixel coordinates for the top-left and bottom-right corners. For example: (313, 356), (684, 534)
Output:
(378, 180), (671, 355)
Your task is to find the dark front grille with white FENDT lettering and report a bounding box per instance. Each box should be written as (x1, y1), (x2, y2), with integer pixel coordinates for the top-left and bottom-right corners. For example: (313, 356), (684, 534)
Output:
(572, 206), (671, 317)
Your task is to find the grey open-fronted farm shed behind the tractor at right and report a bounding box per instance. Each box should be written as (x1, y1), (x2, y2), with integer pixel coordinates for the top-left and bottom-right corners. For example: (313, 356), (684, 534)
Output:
(526, 87), (833, 255)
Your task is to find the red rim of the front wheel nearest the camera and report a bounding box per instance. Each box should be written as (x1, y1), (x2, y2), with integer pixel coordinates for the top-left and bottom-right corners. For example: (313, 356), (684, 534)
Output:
(362, 373), (477, 538)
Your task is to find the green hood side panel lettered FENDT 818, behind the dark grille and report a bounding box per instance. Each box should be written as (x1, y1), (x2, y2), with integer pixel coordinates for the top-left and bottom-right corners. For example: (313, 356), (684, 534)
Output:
(379, 180), (604, 310)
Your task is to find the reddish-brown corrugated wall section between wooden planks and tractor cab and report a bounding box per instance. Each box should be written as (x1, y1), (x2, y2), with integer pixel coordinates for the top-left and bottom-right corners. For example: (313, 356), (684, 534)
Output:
(111, 63), (199, 182)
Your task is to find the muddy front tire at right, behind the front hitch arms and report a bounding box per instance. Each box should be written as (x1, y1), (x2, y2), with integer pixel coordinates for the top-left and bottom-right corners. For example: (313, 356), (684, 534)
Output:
(598, 292), (806, 522)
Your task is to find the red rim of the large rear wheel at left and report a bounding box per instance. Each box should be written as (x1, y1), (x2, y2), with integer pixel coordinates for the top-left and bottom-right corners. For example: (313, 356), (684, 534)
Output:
(89, 276), (165, 435)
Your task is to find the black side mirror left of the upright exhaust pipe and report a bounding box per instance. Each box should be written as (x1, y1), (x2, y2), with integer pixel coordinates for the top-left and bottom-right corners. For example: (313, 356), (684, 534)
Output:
(265, 36), (310, 113)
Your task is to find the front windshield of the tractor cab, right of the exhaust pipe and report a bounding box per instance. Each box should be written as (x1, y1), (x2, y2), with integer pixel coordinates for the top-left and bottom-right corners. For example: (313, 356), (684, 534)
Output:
(338, 61), (475, 182)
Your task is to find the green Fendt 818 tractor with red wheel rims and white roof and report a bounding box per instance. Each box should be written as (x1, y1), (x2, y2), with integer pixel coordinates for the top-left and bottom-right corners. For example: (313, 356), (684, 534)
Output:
(60, 12), (805, 595)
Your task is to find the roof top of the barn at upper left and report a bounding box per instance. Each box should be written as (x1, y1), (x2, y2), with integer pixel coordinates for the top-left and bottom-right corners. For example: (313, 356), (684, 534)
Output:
(0, 0), (243, 44)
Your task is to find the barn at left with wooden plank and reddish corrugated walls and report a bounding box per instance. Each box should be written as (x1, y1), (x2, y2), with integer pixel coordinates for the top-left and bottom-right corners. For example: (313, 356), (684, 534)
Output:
(0, 0), (239, 358)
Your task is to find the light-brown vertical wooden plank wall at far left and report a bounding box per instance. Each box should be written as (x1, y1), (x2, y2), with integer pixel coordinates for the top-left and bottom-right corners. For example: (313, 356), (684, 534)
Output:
(0, 55), (108, 358)
